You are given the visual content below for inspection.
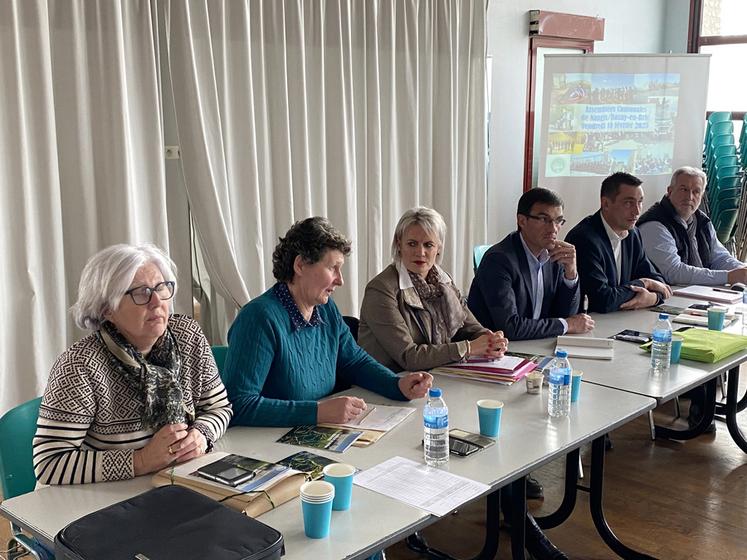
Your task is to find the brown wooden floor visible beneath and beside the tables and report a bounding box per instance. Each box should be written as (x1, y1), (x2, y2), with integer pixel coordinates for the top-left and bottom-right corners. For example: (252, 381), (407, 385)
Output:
(0, 394), (747, 560)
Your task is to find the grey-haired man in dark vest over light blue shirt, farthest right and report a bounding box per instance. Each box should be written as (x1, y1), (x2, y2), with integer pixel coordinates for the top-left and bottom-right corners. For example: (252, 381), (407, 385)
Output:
(638, 167), (747, 286)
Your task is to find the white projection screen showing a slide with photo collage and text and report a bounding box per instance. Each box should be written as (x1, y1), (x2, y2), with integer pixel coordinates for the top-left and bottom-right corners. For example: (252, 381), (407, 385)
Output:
(537, 54), (710, 235)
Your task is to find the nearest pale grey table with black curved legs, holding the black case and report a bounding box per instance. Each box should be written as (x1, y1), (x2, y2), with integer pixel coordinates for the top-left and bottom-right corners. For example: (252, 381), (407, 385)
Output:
(0, 377), (655, 560)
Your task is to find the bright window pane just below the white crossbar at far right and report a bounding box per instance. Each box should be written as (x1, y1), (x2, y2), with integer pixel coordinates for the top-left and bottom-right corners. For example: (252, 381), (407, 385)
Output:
(700, 43), (747, 111)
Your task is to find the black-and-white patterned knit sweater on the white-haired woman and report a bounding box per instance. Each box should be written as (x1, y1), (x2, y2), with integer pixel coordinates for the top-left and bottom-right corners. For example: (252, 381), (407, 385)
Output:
(34, 315), (232, 484)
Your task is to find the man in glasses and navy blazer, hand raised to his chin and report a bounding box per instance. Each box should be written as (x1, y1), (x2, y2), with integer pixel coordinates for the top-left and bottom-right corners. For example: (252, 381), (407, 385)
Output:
(467, 188), (594, 340)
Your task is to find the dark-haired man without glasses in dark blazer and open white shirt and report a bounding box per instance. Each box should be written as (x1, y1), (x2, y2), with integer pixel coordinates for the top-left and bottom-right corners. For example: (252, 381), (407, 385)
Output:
(565, 172), (672, 313)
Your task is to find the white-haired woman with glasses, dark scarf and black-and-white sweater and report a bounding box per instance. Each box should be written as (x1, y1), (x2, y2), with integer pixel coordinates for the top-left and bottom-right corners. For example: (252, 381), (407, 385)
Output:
(34, 244), (232, 484)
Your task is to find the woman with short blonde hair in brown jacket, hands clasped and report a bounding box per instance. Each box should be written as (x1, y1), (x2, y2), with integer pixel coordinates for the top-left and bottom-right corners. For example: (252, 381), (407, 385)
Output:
(358, 207), (508, 371)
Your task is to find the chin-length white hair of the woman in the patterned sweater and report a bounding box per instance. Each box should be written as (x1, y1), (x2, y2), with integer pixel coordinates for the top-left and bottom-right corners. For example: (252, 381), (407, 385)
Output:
(72, 243), (176, 330)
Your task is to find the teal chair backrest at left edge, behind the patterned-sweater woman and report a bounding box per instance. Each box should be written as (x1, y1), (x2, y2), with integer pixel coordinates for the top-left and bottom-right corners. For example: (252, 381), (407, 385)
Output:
(0, 397), (41, 498)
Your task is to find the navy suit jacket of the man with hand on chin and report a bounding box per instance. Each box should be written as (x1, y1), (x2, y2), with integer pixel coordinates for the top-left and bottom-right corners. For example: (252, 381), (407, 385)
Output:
(467, 231), (580, 340)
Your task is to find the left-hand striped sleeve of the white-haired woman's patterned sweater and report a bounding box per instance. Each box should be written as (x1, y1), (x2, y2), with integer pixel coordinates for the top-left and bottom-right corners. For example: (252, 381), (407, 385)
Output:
(33, 349), (134, 484)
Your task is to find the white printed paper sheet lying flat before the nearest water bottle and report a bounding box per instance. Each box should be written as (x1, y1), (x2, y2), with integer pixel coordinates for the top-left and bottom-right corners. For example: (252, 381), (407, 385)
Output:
(353, 457), (490, 517)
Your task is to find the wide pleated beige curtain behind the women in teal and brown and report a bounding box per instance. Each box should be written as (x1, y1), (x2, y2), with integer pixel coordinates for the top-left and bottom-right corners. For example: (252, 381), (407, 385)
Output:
(163, 0), (486, 332)
